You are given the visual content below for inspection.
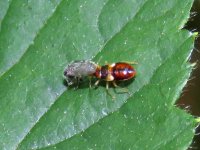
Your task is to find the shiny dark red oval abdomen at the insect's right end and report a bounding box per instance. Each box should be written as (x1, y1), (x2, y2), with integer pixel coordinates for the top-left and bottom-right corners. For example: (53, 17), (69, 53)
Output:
(112, 62), (136, 80)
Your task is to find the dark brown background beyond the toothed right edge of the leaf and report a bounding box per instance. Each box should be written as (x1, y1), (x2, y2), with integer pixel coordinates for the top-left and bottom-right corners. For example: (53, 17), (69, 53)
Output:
(177, 0), (200, 150)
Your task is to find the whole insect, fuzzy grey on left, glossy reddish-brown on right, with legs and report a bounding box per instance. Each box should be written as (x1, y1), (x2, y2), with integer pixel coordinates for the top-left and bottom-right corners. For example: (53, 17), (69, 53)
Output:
(64, 60), (136, 98)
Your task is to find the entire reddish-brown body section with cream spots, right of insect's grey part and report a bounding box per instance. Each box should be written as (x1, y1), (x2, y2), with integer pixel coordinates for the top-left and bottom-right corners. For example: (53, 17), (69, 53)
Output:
(94, 62), (136, 81)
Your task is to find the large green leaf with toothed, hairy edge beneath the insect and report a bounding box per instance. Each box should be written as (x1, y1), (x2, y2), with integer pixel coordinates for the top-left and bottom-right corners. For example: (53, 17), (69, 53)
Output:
(0, 0), (196, 149)
